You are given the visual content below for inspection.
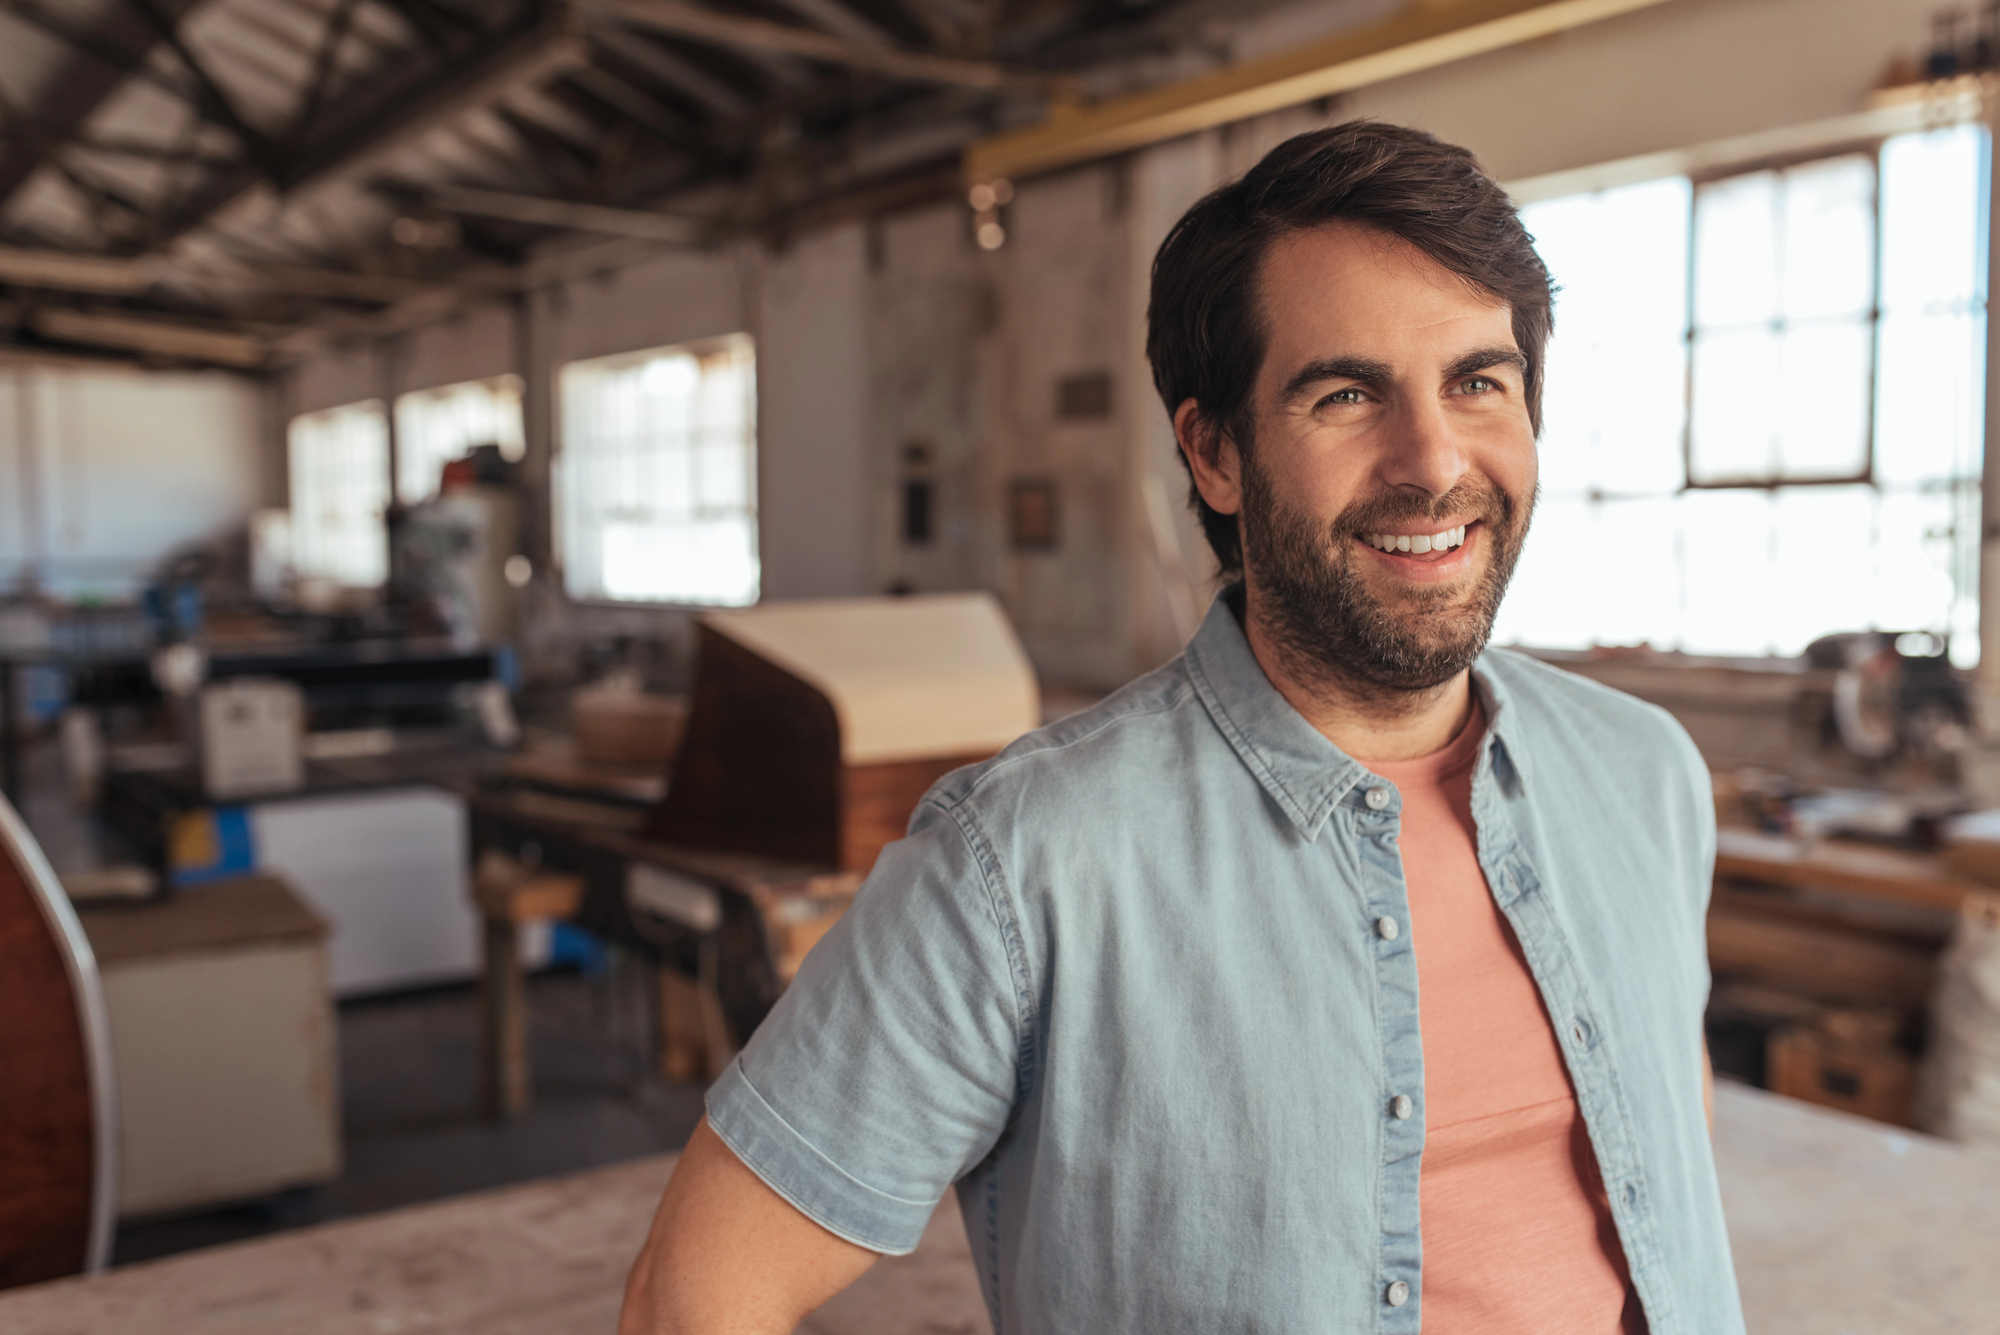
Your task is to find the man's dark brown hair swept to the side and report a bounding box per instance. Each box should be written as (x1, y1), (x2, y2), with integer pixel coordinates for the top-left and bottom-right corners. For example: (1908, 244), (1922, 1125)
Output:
(1146, 120), (1552, 574)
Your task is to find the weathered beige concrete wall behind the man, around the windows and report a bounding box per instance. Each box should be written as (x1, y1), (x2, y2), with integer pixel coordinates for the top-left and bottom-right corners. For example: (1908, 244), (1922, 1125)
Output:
(270, 0), (1936, 685)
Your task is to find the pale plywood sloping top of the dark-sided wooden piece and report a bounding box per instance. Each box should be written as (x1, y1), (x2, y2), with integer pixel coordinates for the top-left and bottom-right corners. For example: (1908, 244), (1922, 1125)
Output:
(702, 594), (1040, 765)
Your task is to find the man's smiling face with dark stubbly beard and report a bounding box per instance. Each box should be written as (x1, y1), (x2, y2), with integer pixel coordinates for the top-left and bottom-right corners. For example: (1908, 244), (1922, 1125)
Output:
(1210, 226), (1536, 691)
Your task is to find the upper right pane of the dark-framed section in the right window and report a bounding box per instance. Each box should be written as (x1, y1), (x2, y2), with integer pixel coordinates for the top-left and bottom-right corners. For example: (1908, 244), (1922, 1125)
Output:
(1778, 154), (1874, 320)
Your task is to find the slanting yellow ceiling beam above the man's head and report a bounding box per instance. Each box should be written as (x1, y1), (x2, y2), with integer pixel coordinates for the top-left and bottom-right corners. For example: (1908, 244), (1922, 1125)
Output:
(964, 0), (1662, 184)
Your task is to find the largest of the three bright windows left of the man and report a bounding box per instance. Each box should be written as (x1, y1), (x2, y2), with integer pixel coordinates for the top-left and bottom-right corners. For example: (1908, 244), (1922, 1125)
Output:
(556, 334), (758, 606)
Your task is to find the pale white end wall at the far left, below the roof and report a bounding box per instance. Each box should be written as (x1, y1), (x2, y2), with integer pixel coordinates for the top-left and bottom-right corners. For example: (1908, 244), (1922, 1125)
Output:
(0, 362), (266, 600)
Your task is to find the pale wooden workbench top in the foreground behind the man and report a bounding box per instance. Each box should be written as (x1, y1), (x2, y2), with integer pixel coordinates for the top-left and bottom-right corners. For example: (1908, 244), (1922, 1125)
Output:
(0, 1083), (2000, 1335)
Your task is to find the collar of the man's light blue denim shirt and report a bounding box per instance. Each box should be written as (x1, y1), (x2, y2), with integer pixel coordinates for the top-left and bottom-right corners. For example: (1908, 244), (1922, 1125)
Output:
(1186, 588), (1520, 841)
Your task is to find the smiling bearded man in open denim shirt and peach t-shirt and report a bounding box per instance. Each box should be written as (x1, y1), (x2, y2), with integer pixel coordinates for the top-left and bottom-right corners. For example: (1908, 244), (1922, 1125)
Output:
(622, 122), (1742, 1335)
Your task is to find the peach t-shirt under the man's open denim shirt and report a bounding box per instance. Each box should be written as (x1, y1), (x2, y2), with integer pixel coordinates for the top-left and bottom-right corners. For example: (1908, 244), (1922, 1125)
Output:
(1368, 701), (1646, 1335)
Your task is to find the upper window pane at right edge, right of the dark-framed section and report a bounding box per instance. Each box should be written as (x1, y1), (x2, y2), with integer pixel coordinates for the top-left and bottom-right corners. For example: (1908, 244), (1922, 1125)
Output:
(1882, 126), (1986, 314)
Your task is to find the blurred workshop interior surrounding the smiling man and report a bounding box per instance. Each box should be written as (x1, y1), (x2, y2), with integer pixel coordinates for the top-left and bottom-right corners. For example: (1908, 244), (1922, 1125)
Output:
(0, 0), (2000, 1333)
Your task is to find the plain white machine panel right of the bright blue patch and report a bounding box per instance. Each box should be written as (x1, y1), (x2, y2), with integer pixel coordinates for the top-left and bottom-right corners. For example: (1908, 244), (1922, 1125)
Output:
(250, 787), (478, 995)
